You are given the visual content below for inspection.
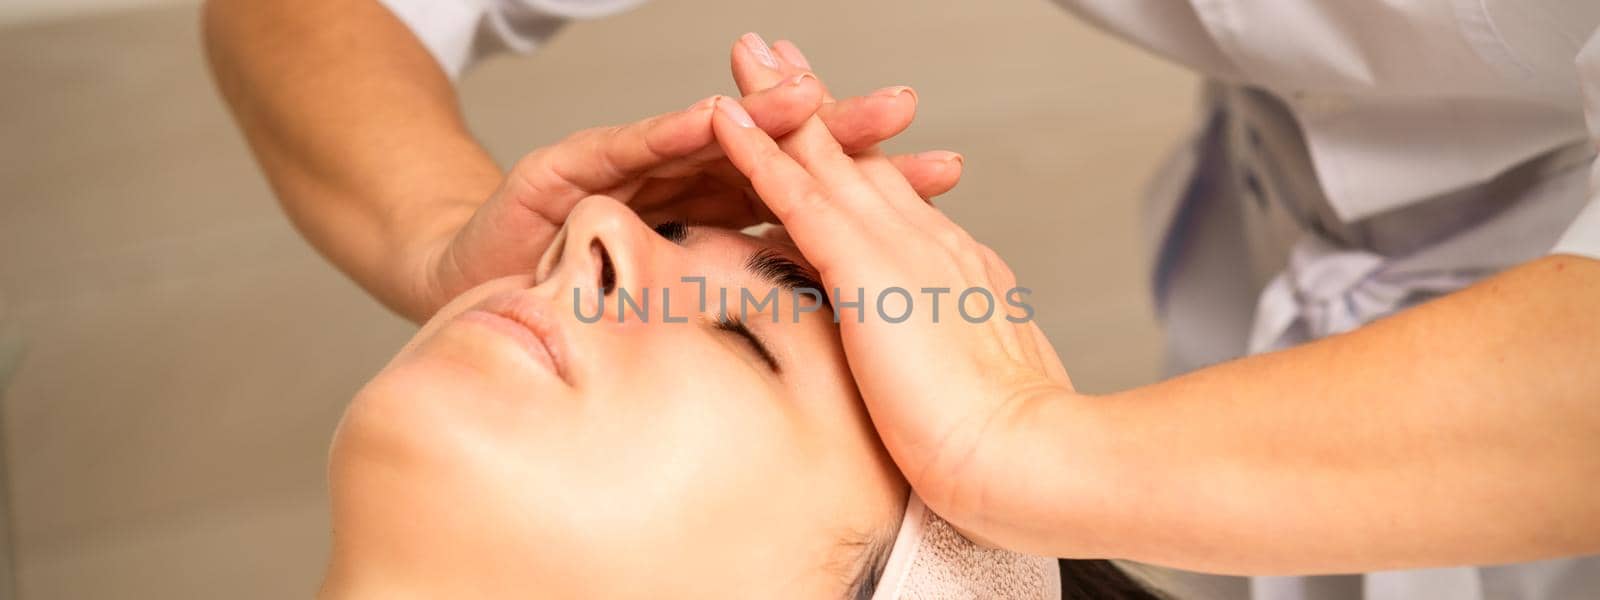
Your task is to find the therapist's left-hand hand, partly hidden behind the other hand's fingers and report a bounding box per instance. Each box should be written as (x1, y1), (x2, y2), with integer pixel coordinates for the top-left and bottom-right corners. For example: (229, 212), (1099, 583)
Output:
(405, 34), (960, 318)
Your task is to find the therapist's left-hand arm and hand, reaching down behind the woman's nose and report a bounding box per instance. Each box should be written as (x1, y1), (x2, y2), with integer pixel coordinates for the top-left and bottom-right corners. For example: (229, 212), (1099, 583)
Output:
(193, 0), (960, 322)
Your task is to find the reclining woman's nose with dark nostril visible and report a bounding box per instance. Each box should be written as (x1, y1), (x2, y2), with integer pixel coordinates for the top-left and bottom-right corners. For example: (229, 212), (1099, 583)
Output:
(534, 195), (656, 298)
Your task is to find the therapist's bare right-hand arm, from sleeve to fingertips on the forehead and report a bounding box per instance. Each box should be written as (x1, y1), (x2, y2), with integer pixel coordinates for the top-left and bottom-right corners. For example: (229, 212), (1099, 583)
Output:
(714, 86), (1600, 574)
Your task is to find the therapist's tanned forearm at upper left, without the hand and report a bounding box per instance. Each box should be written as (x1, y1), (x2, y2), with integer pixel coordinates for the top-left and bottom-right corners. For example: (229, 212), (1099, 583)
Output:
(205, 0), (501, 315)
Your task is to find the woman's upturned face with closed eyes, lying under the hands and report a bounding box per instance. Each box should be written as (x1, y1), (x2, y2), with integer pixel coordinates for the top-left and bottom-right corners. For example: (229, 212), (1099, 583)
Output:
(325, 198), (906, 597)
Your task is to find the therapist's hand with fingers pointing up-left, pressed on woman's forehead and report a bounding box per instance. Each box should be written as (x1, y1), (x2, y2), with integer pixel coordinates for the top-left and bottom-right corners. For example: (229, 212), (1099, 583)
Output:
(714, 101), (1074, 546)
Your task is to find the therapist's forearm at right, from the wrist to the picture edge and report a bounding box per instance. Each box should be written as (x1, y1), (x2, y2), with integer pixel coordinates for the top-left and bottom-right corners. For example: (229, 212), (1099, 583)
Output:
(1034, 256), (1600, 574)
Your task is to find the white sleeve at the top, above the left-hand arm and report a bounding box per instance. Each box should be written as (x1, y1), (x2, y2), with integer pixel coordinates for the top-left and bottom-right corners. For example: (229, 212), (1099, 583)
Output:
(379, 0), (645, 80)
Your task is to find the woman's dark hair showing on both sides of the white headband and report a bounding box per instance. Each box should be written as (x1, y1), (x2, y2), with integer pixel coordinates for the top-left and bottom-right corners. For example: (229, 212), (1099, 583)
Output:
(845, 531), (1166, 600)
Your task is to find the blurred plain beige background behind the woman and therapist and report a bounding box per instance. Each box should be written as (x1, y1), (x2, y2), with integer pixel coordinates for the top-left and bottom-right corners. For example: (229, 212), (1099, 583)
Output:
(0, 0), (1192, 600)
